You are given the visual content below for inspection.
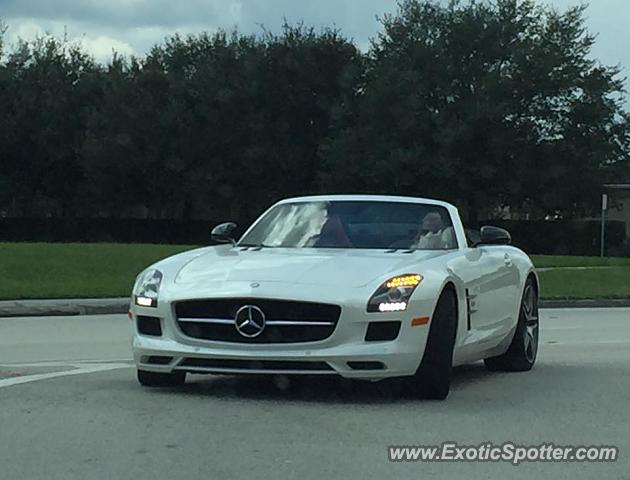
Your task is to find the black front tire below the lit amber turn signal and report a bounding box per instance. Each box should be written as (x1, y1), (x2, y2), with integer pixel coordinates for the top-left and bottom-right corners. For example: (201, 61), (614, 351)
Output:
(411, 288), (457, 400)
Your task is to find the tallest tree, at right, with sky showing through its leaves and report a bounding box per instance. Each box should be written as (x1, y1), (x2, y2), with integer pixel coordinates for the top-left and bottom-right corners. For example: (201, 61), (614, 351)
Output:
(324, 0), (629, 222)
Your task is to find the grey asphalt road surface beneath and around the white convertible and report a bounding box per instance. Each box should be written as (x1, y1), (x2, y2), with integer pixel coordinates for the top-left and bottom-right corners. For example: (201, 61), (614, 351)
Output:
(0, 309), (630, 480)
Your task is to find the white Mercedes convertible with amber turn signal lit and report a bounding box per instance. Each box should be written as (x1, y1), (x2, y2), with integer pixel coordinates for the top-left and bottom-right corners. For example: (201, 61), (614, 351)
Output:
(130, 195), (539, 399)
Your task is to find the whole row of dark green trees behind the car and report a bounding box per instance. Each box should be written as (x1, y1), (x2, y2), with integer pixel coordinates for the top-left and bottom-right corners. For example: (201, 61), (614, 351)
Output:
(0, 0), (630, 225)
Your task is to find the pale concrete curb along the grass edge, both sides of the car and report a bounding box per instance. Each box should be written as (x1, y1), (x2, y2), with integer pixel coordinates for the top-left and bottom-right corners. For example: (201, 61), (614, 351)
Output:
(0, 297), (630, 318)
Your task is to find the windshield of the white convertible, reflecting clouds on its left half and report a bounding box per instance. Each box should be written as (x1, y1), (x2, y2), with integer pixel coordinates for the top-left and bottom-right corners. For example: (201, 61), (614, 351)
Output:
(239, 201), (457, 250)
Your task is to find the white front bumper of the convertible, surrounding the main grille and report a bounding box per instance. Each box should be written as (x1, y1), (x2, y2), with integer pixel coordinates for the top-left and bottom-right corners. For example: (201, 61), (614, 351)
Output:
(131, 284), (434, 380)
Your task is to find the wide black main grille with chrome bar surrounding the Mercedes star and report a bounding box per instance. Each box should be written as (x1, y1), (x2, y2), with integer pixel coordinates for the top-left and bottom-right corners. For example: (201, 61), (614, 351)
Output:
(175, 298), (341, 343)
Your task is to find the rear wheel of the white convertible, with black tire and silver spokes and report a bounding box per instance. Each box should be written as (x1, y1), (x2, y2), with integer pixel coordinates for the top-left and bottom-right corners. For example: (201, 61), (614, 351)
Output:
(484, 277), (539, 372)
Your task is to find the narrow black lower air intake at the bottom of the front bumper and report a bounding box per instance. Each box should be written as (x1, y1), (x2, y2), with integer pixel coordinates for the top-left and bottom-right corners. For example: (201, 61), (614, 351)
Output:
(178, 358), (334, 372)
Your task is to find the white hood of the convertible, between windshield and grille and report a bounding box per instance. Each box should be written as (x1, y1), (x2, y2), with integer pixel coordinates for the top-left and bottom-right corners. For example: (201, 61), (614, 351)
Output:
(175, 247), (446, 287)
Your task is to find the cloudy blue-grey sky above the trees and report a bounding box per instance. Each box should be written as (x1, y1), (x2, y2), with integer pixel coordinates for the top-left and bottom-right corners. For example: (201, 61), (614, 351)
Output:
(0, 0), (630, 87)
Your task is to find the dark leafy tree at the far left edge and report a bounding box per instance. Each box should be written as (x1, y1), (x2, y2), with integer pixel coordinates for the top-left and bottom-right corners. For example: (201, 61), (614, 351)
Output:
(0, 37), (99, 216)
